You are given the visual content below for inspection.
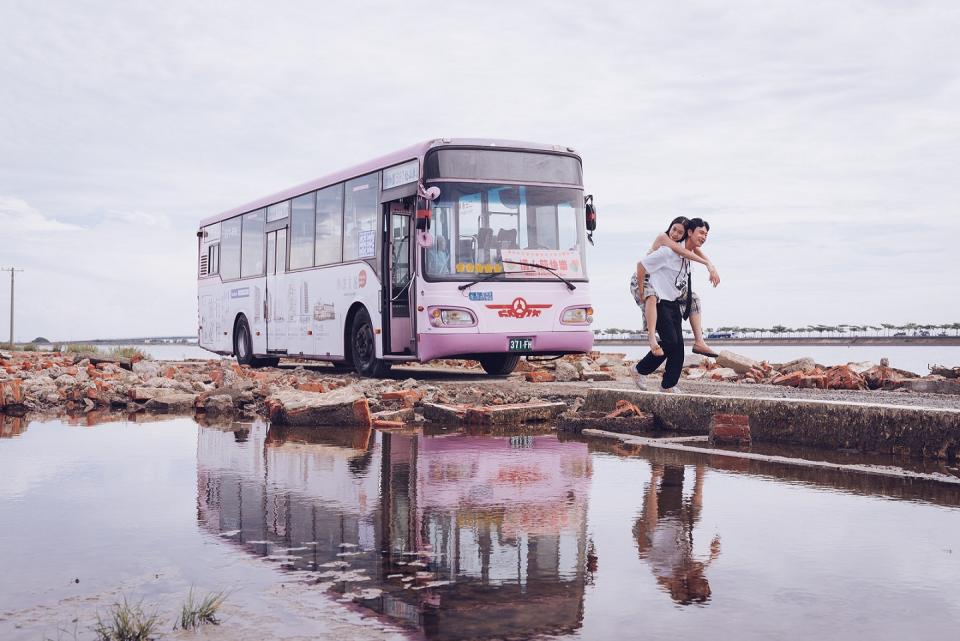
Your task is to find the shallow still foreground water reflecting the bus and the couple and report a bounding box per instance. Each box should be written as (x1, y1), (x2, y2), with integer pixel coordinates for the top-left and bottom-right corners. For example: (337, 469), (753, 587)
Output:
(0, 418), (960, 640)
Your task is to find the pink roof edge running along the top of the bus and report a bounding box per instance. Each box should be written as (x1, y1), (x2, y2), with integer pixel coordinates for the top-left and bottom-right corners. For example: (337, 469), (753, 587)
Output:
(200, 138), (579, 227)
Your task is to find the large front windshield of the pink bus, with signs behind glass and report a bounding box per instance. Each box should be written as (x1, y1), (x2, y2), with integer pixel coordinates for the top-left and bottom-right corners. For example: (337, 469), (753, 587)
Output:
(424, 182), (586, 280)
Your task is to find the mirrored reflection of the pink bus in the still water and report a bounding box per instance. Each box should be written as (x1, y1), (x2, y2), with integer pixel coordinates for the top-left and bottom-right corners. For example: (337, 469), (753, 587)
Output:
(198, 424), (591, 639)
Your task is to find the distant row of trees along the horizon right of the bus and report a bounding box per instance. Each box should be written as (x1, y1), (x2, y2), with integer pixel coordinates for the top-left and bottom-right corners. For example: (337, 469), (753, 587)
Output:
(593, 323), (960, 338)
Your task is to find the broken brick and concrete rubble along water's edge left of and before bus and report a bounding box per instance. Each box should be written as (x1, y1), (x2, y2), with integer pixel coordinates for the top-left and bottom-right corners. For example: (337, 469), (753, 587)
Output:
(0, 352), (566, 428)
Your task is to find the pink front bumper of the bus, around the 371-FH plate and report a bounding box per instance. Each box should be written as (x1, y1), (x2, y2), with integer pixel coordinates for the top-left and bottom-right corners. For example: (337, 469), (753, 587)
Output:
(417, 330), (593, 363)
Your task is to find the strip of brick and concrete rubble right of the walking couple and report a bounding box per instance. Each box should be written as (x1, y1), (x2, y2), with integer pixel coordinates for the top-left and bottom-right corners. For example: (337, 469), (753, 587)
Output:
(684, 351), (956, 391)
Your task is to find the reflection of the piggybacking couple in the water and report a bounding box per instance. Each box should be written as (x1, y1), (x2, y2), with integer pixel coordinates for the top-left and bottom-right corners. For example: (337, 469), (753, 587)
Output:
(633, 465), (720, 605)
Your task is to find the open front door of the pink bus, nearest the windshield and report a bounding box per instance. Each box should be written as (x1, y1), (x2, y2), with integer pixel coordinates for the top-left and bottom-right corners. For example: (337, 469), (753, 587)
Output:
(383, 198), (416, 355)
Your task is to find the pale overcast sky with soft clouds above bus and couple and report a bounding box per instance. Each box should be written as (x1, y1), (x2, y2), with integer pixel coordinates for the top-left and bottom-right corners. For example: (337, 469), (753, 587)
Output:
(0, 0), (960, 340)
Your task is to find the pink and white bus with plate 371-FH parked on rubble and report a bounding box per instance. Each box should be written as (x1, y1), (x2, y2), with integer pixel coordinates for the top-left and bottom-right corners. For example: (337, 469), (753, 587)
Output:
(197, 138), (595, 376)
